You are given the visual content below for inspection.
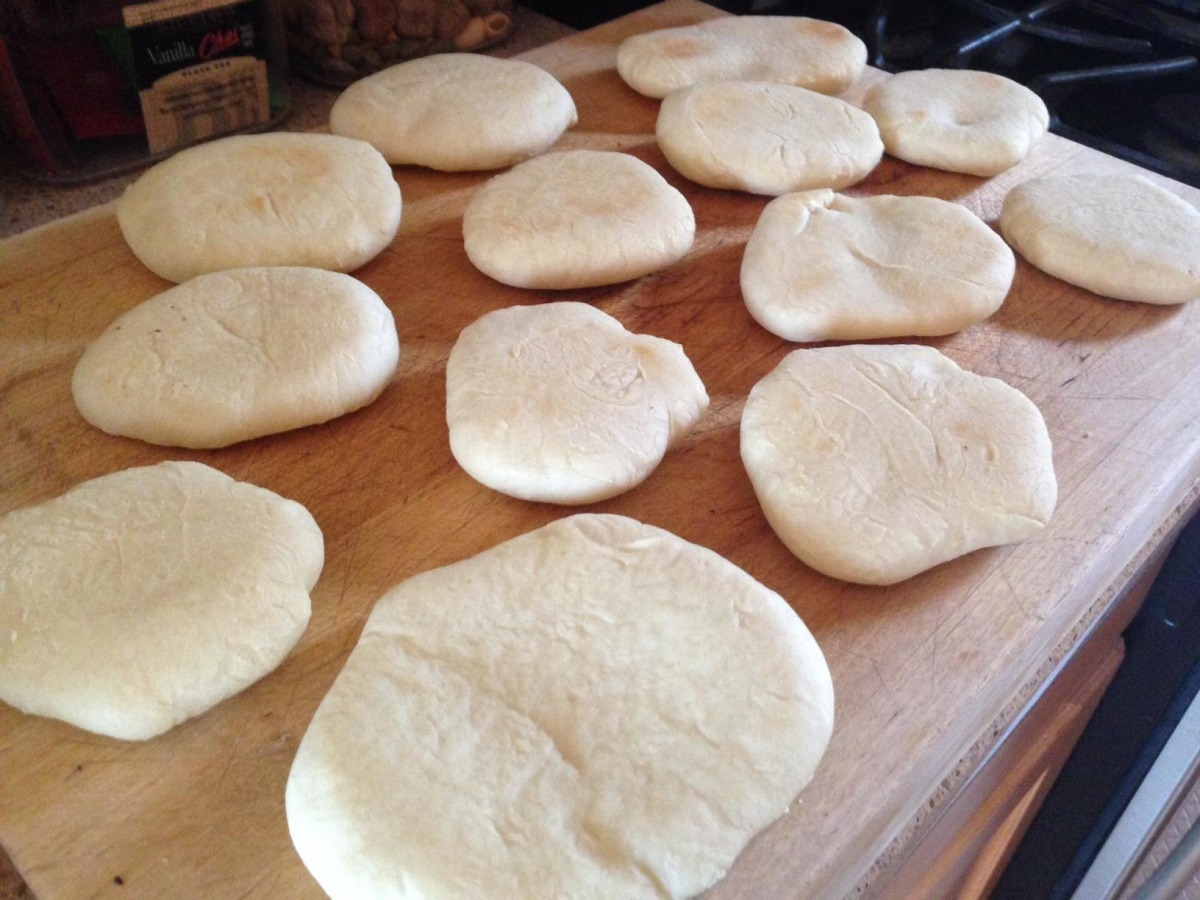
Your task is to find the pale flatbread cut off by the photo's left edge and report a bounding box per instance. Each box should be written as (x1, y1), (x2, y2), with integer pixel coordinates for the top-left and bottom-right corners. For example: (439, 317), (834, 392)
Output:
(0, 462), (324, 740)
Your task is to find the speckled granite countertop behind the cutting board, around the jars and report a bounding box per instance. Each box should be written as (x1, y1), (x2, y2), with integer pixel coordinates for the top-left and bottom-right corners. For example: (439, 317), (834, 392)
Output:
(0, 6), (575, 241)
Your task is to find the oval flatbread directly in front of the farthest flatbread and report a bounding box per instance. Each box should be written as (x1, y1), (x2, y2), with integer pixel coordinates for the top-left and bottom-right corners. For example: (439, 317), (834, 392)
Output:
(655, 82), (883, 196)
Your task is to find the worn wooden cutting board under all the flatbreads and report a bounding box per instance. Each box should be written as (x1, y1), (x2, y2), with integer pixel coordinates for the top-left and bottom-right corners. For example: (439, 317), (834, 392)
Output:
(7, 0), (1200, 900)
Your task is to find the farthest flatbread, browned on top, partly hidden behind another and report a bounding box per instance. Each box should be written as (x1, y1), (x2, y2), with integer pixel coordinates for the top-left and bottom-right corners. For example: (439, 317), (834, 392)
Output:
(617, 16), (866, 98)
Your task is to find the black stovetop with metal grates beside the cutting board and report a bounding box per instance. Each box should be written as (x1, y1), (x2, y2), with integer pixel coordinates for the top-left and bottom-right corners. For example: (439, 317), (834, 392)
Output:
(859, 0), (1200, 186)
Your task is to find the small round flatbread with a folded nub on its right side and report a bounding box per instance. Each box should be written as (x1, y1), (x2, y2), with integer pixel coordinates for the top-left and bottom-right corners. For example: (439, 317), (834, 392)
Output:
(446, 302), (708, 504)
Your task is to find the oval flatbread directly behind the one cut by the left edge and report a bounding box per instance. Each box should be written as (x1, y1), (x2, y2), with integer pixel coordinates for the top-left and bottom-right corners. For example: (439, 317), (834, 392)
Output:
(71, 268), (400, 448)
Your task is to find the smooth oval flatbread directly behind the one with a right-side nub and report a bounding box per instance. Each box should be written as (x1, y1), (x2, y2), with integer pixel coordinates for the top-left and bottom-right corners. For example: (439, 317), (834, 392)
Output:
(462, 150), (696, 289)
